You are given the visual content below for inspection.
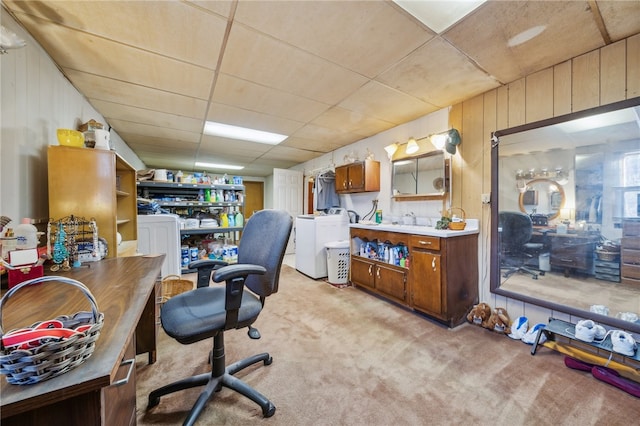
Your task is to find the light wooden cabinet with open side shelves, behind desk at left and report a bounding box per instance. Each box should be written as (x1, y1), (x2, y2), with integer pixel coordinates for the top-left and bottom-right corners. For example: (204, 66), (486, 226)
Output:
(48, 146), (138, 257)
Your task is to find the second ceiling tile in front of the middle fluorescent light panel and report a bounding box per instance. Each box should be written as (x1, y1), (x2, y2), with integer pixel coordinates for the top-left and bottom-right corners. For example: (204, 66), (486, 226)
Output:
(212, 74), (329, 122)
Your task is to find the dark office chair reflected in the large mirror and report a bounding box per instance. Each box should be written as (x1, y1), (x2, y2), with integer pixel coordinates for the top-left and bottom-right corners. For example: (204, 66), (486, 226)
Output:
(498, 211), (544, 280)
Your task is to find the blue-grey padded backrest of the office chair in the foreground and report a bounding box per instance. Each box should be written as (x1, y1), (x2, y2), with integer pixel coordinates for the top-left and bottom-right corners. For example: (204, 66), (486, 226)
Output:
(238, 210), (293, 298)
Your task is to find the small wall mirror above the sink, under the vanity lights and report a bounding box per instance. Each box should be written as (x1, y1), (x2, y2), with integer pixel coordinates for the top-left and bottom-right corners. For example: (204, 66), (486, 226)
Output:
(391, 150), (450, 200)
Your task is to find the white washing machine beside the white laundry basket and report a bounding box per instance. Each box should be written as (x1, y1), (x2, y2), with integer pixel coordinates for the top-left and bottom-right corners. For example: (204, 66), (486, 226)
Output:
(295, 208), (349, 279)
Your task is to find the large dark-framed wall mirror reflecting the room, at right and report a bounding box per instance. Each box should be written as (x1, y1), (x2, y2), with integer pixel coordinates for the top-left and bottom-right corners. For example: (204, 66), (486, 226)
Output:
(490, 98), (640, 332)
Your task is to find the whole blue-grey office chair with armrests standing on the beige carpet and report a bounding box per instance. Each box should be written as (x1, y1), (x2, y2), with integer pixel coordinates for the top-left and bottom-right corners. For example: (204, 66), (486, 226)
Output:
(147, 210), (293, 425)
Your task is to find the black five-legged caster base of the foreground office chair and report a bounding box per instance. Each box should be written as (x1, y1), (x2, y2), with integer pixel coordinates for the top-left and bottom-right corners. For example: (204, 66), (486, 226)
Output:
(147, 333), (276, 425)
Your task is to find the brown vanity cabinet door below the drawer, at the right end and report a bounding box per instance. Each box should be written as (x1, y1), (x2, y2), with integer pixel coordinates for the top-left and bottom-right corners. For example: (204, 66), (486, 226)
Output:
(411, 249), (444, 315)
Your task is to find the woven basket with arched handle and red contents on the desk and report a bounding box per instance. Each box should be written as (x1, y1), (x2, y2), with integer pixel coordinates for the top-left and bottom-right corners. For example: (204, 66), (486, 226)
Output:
(0, 276), (104, 385)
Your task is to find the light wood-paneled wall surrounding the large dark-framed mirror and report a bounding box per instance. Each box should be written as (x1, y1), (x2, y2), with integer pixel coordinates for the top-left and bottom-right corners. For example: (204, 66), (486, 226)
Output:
(450, 35), (640, 324)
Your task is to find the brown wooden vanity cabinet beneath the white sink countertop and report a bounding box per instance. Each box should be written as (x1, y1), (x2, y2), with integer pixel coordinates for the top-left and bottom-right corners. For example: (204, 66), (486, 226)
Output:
(350, 226), (478, 327)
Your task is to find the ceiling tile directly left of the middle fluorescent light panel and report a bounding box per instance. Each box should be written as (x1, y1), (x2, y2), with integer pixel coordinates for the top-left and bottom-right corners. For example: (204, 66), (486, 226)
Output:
(91, 100), (204, 133)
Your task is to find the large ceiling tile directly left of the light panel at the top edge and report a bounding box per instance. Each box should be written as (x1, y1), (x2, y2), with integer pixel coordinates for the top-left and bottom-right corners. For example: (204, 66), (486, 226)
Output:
(235, 1), (433, 78)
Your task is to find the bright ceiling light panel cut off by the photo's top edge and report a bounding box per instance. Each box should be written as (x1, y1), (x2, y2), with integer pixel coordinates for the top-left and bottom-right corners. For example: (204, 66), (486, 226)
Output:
(393, 0), (486, 34)
